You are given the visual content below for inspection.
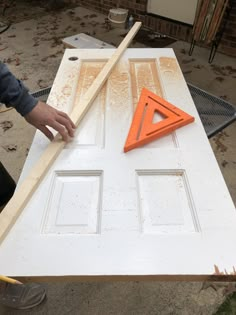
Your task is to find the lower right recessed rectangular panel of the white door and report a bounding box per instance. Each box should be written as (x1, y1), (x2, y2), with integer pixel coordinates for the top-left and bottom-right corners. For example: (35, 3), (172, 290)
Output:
(137, 170), (198, 233)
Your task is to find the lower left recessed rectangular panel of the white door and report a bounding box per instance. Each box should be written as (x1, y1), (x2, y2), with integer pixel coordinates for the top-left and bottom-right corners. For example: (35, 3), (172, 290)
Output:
(42, 171), (102, 234)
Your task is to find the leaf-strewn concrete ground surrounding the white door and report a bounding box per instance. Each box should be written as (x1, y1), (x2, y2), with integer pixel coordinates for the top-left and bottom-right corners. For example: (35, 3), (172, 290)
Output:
(0, 1), (236, 315)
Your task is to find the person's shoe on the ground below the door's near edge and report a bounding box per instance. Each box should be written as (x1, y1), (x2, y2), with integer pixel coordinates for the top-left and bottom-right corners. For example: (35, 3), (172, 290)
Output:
(0, 282), (46, 310)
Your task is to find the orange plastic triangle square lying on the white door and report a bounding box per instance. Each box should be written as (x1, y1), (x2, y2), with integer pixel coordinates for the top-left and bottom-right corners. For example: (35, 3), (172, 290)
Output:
(124, 88), (194, 152)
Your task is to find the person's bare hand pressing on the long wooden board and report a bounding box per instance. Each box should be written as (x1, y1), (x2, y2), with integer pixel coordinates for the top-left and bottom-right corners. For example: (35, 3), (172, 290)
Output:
(25, 101), (75, 141)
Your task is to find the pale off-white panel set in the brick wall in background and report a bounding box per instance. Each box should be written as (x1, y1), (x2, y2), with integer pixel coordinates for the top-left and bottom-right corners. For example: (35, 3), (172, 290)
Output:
(148, 0), (198, 24)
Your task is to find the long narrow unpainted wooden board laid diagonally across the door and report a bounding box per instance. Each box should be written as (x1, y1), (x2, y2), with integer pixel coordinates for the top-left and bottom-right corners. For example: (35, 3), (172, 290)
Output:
(0, 22), (141, 243)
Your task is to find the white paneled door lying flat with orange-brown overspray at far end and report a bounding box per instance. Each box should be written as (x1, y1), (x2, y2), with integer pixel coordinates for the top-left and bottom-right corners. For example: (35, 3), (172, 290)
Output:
(0, 49), (236, 279)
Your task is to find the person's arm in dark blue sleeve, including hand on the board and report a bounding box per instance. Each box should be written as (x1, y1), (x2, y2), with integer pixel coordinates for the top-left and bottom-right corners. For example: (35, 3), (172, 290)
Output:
(0, 62), (75, 141)
